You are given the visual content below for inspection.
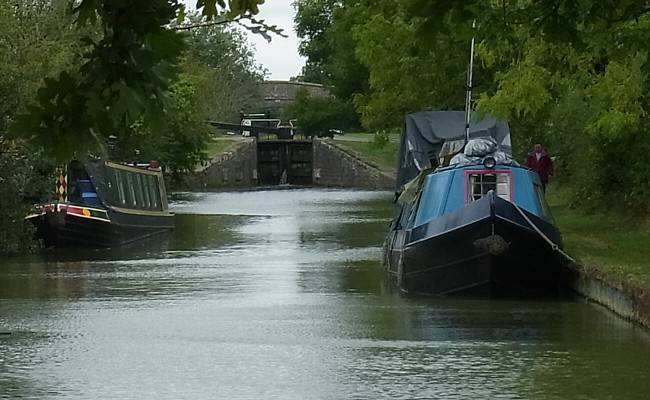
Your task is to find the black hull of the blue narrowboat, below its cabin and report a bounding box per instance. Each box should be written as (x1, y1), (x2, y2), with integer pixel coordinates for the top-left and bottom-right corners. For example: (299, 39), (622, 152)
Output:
(388, 195), (562, 294)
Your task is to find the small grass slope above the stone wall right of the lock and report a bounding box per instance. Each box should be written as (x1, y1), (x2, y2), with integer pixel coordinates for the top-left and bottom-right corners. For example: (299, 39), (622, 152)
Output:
(334, 133), (399, 174)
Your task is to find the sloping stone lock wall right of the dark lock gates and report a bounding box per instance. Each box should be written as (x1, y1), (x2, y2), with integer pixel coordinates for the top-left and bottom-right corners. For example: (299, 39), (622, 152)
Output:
(313, 139), (395, 190)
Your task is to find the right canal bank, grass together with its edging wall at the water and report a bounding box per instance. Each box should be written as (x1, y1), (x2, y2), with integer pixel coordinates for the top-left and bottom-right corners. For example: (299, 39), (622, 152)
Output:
(547, 189), (650, 328)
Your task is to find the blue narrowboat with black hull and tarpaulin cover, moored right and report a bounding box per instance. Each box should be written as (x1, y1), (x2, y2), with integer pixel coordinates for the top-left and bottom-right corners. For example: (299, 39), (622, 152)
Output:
(385, 111), (565, 295)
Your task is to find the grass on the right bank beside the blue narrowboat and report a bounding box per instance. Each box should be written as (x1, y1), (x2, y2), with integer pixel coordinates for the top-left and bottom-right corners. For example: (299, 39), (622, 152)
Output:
(547, 186), (650, 288)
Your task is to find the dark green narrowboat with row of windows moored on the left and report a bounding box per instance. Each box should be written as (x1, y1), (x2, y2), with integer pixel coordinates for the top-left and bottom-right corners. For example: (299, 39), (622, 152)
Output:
(26, 159), (174, 248)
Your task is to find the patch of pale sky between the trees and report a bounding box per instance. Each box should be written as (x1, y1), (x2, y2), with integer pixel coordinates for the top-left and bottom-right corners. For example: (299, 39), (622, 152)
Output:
(248, 0), (305, 80)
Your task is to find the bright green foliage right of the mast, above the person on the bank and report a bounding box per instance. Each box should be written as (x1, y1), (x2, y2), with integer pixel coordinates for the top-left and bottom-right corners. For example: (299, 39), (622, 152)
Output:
(468, 2), (650, 209)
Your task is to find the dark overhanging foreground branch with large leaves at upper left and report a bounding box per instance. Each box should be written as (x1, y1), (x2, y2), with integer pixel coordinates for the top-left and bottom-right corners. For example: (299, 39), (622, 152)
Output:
(15, 0), (270, 159)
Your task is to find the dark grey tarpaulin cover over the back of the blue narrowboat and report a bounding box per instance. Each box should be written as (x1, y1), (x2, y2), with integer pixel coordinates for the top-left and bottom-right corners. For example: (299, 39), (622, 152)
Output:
(396, 111), (512, 191)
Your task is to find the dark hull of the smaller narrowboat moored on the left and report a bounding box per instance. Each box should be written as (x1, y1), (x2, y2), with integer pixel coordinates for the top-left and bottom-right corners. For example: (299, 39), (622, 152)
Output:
(27, 207), (174, 248)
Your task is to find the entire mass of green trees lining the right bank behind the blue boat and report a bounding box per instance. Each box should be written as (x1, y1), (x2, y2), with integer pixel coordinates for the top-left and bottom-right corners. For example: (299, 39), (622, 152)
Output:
(296, 0), (650, 213)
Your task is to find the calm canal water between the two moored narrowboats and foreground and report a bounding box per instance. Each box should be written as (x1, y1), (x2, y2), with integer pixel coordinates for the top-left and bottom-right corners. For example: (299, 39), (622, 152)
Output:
(0, 190), (650, 399)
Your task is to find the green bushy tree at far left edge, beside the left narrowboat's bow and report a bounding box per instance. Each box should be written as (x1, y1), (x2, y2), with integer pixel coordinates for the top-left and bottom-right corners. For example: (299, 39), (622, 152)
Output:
(0, 0), (95, 253)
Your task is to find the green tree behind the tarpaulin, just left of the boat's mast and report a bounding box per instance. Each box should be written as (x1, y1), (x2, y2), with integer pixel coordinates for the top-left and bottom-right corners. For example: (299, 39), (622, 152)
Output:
(352, 1), (469, 130)
